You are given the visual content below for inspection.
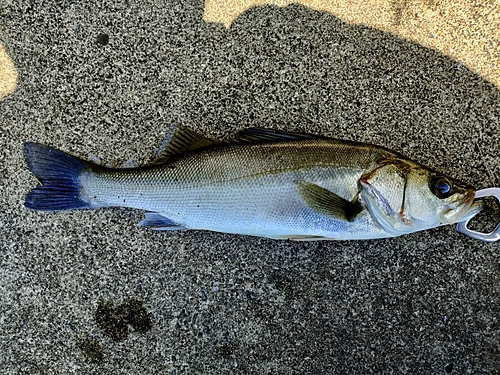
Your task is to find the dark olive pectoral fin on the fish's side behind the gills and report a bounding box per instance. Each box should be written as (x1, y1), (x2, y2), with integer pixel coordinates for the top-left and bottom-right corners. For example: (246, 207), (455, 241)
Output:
(295, 181), (363, 221)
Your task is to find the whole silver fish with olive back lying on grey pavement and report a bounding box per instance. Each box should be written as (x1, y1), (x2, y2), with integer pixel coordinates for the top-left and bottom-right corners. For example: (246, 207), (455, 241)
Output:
(24, 126), (482, 241)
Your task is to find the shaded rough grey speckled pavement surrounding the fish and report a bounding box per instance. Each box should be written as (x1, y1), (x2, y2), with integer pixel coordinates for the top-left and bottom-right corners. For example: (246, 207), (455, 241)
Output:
(0, 1), (500, 375)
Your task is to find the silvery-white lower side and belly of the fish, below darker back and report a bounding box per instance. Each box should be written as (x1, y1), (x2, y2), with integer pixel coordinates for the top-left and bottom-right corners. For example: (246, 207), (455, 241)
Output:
(86, 169), (391, 239)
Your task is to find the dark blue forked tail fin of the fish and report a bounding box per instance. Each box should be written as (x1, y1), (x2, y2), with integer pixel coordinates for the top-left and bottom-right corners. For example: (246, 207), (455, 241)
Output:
(24, 142), (91, 211)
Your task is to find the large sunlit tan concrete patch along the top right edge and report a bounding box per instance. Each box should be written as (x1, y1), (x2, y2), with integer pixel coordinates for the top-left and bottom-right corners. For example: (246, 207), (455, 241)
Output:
(203, 0), (500, 86)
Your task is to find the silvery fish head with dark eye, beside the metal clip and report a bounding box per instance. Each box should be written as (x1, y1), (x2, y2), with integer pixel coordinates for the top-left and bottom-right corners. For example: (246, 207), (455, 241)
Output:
(359, 160), (482, 235)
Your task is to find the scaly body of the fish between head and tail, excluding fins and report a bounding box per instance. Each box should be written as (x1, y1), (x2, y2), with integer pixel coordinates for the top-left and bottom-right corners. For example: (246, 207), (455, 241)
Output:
(81, 140), (398, 237)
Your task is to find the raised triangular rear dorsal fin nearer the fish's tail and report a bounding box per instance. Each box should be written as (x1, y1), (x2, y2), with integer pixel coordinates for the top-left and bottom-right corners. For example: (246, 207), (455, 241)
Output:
(153, 125), (221, 164)
